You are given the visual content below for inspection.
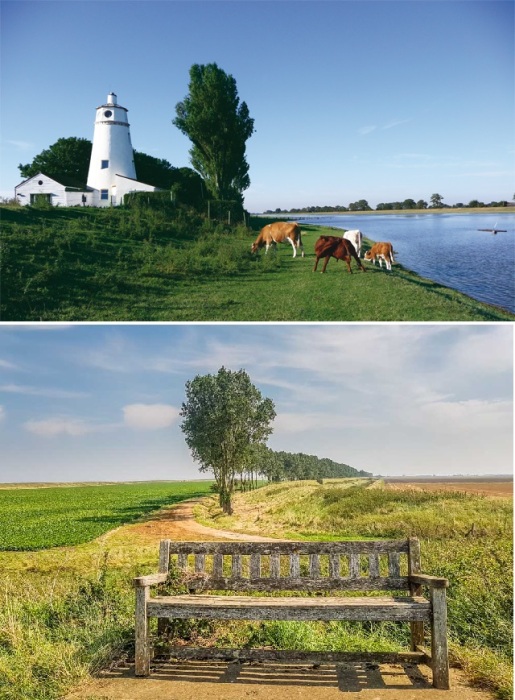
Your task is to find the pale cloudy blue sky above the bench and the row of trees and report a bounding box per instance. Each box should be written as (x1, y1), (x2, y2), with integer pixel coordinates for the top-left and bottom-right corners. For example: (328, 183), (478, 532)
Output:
(0, 324), (513, 482)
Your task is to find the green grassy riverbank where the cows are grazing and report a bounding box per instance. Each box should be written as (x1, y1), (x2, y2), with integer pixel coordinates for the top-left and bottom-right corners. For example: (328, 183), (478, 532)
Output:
(0, 207), (515, 321)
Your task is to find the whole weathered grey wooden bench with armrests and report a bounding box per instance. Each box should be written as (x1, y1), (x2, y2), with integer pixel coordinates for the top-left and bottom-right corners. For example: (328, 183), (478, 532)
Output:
(134, 538), (449, 689)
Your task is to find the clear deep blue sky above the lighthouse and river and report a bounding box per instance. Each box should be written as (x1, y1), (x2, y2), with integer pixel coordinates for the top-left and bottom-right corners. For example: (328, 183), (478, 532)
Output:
(0, 0), (515, 211)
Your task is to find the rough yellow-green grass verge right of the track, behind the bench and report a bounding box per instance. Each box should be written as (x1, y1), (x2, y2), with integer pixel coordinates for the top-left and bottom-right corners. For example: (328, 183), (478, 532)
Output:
(192, 480), (513, 700)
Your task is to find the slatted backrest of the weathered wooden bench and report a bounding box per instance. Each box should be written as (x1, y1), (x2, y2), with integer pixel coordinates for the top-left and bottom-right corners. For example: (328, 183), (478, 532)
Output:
(159, 537), (420, 591)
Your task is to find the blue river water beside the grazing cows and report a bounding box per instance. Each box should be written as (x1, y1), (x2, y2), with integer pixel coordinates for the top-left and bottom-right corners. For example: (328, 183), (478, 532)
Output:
(292, 213), (515, 313)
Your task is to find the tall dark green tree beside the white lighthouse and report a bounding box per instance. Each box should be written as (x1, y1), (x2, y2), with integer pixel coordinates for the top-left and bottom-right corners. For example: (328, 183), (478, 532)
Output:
(173, 63), (254, 203)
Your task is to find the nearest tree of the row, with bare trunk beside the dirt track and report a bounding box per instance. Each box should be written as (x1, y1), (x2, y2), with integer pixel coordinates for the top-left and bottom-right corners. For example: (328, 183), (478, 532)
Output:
(180, 367), (276, 514)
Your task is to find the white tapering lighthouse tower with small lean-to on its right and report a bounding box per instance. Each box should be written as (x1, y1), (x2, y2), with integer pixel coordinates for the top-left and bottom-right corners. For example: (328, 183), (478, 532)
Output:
(87, 92), (156, 206)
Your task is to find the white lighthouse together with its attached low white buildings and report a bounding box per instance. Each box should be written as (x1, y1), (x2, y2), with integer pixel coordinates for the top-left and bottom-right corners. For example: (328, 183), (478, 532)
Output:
(15, 92), (159, 207)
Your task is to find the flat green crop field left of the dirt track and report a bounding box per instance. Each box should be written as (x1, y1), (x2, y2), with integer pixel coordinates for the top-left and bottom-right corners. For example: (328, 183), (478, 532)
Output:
(0, 481), (211, 551)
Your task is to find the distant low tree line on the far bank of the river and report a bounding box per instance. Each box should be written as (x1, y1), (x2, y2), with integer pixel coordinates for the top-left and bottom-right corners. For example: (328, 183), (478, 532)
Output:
(264, 194), (510, 214)
